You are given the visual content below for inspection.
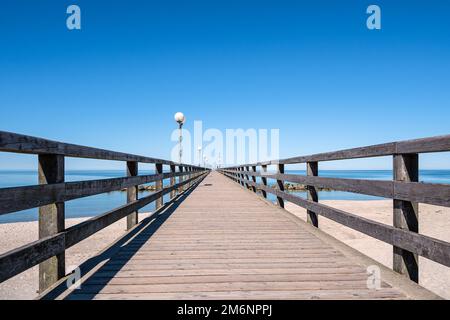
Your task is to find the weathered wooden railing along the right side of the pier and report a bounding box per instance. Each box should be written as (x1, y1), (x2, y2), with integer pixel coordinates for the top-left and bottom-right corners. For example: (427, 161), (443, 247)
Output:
(219, 135), (450, 282)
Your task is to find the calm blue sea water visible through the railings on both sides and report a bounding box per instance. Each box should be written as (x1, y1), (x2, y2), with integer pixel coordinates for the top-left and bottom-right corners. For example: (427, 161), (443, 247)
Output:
(0, 170), (450, 223)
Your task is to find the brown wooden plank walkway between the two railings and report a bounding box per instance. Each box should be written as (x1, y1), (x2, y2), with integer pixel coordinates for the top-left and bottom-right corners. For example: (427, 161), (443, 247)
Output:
(52, 172), (436, 299)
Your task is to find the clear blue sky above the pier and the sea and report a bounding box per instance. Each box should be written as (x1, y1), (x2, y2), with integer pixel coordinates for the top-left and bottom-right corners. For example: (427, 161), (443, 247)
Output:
(0, 0), (450, 169)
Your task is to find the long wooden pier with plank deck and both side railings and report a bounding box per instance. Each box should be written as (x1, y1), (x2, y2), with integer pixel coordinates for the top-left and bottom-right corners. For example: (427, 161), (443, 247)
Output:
(0, 132), (450, 300)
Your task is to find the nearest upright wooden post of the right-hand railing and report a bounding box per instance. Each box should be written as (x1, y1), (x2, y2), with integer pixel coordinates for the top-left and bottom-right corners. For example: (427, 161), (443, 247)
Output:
(393, 154), (419, 283)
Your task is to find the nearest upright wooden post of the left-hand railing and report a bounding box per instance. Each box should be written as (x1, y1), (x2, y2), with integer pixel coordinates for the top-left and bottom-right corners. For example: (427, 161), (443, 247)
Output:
(38, 154), (66, 292)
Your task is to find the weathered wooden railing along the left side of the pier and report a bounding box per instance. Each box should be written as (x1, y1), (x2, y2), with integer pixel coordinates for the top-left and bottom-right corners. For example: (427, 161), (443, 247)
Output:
(0, 131), (209, 292)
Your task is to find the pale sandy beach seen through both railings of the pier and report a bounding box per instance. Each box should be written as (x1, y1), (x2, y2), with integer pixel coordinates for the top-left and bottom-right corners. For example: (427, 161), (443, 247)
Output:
(0, 200), (450, 299)
